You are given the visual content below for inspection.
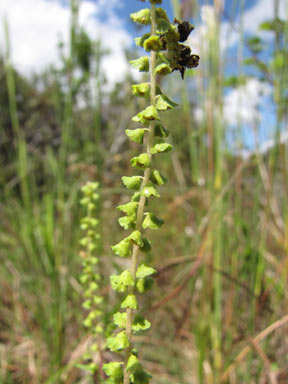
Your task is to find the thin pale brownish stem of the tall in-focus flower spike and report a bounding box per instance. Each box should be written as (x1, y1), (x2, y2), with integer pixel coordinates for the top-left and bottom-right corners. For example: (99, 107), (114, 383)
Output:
(124, 4), (156, 384)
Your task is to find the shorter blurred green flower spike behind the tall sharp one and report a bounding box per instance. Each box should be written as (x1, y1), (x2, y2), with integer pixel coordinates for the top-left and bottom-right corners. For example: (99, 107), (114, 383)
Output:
(78, 182), (103, 374)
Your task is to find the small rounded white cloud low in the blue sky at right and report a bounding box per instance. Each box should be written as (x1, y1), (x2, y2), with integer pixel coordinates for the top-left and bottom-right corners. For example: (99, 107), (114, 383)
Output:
(224, 79), (271, 126)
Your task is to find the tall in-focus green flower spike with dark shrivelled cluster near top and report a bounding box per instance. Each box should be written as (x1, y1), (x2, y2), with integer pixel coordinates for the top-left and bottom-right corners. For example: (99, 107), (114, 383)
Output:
(104, 0), (199, 384)
